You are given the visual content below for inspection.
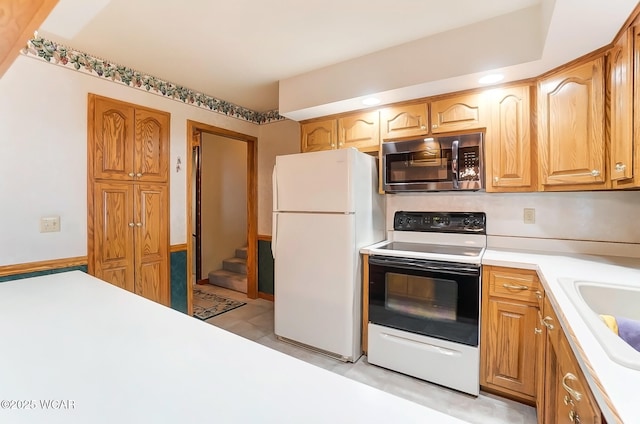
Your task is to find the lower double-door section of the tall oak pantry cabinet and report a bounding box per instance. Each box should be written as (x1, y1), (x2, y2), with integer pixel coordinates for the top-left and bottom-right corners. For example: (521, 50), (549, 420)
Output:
(92, 182), (170, 305)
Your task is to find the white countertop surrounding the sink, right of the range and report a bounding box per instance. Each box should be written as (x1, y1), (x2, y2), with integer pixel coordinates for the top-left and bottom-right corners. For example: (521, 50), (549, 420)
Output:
(482, 241), (640, 424)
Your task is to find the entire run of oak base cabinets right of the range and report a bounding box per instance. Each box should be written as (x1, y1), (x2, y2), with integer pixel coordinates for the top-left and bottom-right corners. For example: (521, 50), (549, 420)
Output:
(480, 265), (604, 424)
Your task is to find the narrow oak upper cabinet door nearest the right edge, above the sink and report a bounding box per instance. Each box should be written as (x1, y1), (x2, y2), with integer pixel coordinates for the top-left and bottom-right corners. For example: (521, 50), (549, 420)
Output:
(608, 27), (634, 181)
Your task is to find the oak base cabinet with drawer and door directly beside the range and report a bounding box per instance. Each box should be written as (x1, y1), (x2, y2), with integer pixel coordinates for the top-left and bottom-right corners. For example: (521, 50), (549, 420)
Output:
(480, 266), (541, 404)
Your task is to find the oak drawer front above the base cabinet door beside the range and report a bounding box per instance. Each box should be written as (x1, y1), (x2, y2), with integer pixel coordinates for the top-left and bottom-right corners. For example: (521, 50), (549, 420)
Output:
(489, 267), (541, 303)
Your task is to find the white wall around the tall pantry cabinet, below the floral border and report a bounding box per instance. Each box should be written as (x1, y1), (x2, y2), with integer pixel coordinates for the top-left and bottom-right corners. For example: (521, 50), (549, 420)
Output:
(0, 56), (260, 266)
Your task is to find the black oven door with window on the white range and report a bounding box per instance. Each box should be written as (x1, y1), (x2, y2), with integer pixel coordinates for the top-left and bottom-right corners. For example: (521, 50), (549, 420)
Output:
(369, 256), (481, 346)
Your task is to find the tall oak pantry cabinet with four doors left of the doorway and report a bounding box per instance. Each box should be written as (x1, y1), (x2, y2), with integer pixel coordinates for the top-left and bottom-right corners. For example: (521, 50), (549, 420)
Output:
(87, 94), (170, 305)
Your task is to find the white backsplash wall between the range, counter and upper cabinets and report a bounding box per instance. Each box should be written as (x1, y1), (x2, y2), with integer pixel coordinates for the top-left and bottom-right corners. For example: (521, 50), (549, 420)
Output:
(387, 191), (640, 243)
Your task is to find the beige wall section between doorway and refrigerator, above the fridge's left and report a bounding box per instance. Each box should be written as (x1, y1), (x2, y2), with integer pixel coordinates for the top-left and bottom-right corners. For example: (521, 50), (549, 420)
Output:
(258, 120), (300, 235)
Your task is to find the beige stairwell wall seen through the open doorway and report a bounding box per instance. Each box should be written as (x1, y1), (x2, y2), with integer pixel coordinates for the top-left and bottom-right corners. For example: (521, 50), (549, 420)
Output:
(201, 133), (247, 278)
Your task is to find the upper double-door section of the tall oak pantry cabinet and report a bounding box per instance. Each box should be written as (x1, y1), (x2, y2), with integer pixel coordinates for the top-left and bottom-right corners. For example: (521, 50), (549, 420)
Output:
(89, 95), (169, 182)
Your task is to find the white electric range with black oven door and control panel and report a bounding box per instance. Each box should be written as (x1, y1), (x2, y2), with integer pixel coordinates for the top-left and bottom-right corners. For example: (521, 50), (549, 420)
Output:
(361, 211), (487, 395)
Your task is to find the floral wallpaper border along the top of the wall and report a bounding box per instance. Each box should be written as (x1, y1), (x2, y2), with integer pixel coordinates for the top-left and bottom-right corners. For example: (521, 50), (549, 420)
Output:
(22, 37), (286, 124)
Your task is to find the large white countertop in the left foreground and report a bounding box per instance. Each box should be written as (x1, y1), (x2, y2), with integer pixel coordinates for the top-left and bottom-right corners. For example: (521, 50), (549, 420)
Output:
(0, 271), (470, 424)
